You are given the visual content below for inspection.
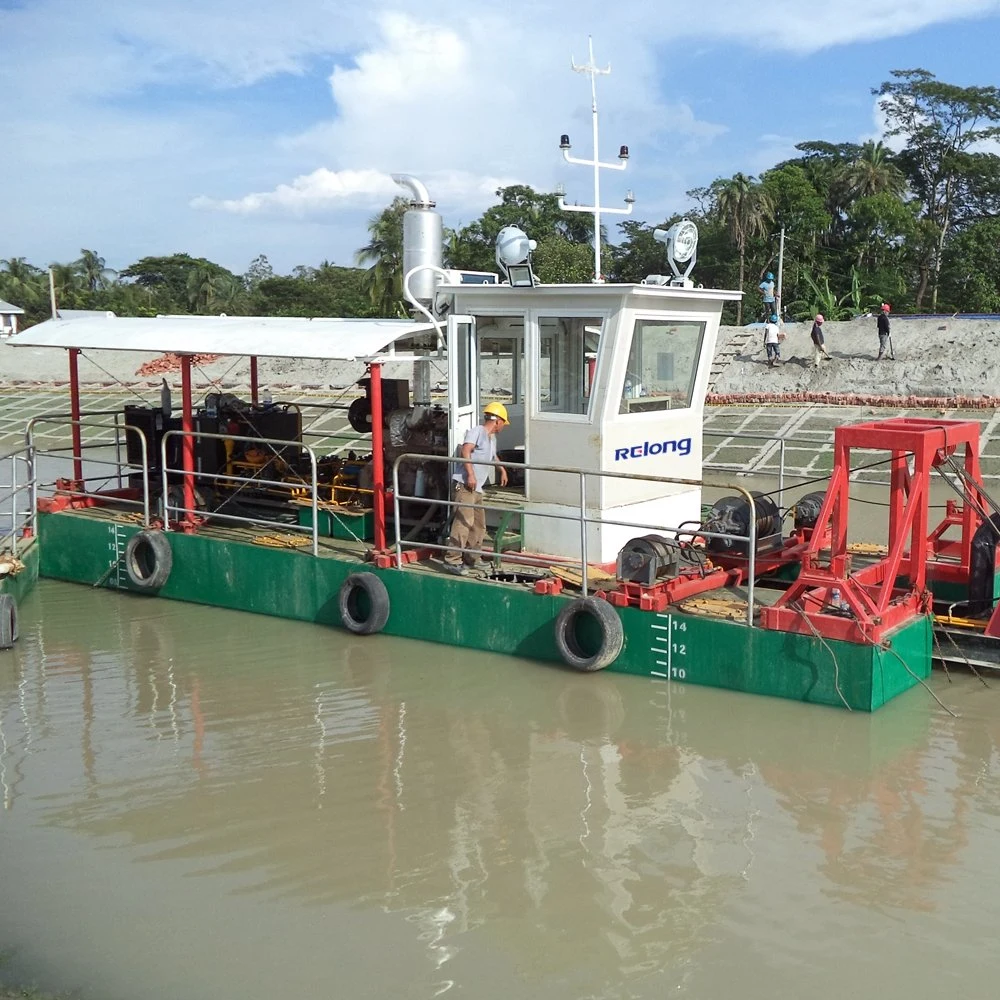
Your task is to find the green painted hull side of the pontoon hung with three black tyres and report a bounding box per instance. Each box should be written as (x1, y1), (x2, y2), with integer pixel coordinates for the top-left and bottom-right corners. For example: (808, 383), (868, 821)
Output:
(39, 513), (932, 711)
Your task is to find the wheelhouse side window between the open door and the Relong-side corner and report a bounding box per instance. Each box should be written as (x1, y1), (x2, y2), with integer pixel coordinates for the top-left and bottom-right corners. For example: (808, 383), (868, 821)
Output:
(537, 316), (604, 413)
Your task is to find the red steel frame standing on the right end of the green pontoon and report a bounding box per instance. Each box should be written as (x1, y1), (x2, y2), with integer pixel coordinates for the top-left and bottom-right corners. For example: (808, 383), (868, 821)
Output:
(761, 417), (985, 643)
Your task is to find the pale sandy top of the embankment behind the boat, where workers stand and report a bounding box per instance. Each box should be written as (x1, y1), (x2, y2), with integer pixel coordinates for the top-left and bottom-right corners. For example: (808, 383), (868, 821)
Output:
(0, 317), (1000, 401)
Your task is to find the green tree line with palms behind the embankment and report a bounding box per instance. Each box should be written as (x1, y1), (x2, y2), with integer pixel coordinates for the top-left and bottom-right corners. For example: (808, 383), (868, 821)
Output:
(0, 69), (1000, 323)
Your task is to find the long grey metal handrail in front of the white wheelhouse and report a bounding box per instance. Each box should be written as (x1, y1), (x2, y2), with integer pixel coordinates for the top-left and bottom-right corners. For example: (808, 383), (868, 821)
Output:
(392, 452), (757, 627)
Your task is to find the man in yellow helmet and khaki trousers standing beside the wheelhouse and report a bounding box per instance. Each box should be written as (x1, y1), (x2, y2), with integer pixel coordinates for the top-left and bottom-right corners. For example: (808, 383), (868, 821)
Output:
(444, 403), (509, 576)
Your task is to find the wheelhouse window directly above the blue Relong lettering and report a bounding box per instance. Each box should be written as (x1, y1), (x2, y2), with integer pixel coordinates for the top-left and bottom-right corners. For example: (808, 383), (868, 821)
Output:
(618, 319), (705, 413)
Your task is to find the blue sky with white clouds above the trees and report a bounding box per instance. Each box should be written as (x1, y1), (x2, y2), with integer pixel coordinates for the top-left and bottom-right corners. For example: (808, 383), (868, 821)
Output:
(0, 0), (1000, 273)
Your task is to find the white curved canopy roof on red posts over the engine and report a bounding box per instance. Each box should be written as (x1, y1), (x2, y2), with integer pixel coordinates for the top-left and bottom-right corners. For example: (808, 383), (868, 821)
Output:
(8, 313), (434, 361)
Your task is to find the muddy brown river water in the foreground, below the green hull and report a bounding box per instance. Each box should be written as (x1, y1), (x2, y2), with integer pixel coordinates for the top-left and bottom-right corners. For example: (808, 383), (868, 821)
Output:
(0, 582), (1000, 1000)
